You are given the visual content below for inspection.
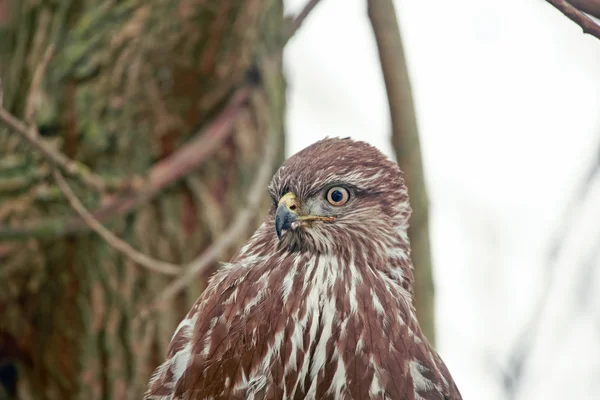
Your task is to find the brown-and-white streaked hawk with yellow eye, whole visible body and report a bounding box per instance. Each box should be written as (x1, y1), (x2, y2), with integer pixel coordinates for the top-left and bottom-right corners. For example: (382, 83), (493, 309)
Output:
(145, 138), (461, 400)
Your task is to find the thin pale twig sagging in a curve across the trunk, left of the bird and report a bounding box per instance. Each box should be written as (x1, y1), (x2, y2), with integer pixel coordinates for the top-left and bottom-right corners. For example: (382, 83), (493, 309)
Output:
(52, 169), (182, 275)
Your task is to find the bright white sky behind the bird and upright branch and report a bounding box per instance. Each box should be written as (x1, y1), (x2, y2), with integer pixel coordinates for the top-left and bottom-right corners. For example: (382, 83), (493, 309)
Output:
(285, 0), (600, 400)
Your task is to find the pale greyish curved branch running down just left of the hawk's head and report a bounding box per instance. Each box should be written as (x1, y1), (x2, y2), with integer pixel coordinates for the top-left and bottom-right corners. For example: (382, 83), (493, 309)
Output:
(137, 131), (277, 319)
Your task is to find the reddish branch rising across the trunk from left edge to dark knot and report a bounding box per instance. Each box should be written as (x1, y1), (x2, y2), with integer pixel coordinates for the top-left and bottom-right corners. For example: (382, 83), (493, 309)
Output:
(0, 87), (251, 239)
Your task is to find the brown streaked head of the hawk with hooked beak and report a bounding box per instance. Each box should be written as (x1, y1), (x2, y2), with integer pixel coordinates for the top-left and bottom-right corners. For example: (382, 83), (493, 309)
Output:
(269, 138), (410, 253)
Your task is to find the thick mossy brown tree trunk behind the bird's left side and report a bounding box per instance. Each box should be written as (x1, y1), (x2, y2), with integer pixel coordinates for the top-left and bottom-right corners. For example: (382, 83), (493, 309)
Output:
(0, 0), (285, 400)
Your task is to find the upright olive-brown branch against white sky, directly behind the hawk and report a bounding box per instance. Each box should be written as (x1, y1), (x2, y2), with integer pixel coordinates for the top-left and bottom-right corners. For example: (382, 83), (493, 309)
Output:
(368, 0), (435, 343)
